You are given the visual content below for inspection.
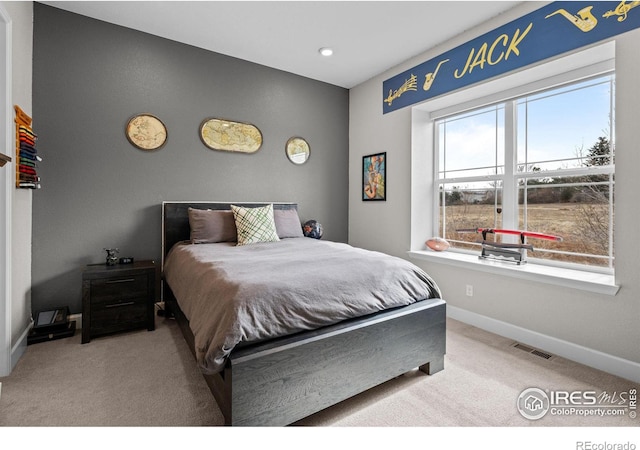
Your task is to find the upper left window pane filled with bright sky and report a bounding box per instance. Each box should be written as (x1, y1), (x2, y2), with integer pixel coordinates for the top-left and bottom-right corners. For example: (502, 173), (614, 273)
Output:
(438, 106), (504, 179)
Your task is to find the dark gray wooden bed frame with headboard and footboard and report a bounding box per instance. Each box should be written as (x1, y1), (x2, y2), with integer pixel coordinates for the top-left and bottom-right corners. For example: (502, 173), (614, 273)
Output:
(162, 202), (446, 426)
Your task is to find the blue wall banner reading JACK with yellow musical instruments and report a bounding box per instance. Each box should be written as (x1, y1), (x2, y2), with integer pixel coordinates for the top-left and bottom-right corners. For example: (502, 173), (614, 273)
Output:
(382, 1), (640, 114)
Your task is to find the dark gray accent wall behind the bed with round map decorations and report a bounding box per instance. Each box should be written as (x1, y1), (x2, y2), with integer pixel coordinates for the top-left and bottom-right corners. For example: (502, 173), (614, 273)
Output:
(31, 3), (349, 313)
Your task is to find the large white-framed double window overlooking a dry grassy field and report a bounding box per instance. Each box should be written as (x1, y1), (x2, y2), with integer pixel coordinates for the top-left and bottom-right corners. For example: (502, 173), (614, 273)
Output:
(434, 73), (615, 271)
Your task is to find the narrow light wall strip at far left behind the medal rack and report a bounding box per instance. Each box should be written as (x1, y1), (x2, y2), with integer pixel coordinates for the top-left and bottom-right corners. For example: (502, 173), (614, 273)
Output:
(2, 2), (32, 370)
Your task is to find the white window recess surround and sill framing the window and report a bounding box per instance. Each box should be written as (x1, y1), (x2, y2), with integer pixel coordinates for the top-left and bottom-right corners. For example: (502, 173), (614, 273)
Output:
(410, 39), (620, 296)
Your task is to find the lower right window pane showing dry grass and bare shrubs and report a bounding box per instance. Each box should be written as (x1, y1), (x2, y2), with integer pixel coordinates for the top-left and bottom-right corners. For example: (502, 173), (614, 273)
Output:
(518, 175), (613, 267)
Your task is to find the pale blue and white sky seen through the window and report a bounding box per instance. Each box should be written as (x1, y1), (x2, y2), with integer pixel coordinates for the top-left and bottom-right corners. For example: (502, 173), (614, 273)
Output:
(438, 74), (611, 176)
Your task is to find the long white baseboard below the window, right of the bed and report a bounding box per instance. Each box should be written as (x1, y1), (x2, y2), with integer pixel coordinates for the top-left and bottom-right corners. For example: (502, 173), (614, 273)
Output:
(447, 305), (640, 383)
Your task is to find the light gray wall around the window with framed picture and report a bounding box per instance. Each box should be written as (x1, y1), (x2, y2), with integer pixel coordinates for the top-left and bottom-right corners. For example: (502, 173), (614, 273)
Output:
(349, 2), (640, 376)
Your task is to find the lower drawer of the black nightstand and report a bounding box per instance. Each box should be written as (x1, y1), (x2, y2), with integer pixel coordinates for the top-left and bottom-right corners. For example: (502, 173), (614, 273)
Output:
(91, 299), (148, 334)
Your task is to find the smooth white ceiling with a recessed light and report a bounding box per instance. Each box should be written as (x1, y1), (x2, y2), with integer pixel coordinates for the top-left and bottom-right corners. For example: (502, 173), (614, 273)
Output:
(41, 1), (522, 88)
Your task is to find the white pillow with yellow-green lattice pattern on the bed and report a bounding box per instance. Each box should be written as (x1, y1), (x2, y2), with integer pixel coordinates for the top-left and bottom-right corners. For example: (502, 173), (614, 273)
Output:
(231, 205), (280, 245)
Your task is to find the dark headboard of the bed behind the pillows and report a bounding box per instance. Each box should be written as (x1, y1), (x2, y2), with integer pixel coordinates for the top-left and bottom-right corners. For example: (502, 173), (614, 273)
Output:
(162, 202), (298, 268)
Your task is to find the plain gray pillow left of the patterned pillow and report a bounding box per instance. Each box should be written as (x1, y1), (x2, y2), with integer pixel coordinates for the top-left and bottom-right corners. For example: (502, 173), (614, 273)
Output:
(189, 208), (237, 244)
